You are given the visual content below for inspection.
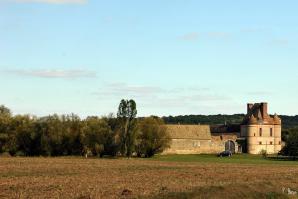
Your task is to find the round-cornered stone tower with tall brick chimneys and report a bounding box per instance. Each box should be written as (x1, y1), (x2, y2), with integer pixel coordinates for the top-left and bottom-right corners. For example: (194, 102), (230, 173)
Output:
(240, 103), (281, 154)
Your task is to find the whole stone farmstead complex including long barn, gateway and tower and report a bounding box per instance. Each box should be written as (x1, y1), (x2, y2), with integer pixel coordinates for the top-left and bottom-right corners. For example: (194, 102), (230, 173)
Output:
(164, 103), (281, 154)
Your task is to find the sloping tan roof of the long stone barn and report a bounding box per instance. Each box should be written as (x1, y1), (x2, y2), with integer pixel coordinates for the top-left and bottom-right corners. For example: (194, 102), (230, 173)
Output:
(166, 125), (211, 140)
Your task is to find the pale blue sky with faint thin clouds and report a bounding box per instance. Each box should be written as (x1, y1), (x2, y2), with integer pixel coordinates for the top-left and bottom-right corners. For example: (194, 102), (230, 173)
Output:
(0, 0), (298, 117)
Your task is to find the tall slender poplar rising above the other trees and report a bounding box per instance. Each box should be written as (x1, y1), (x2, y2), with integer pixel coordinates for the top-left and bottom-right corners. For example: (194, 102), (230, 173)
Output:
(117, 99), (137, 157)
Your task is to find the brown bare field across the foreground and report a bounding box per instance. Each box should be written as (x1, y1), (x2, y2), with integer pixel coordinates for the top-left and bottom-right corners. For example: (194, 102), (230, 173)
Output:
(0, 157), (298, 199)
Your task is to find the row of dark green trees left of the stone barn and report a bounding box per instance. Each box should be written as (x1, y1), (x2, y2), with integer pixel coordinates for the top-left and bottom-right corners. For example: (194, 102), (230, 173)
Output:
(0, 100), (170, 157)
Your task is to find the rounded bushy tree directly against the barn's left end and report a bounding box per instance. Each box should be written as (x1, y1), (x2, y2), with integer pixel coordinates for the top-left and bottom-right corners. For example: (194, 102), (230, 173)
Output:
(136, 117), (171, 157)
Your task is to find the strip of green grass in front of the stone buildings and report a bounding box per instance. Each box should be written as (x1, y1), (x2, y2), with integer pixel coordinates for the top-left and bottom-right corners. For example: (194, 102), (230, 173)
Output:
(152, 154), (298, 165)
